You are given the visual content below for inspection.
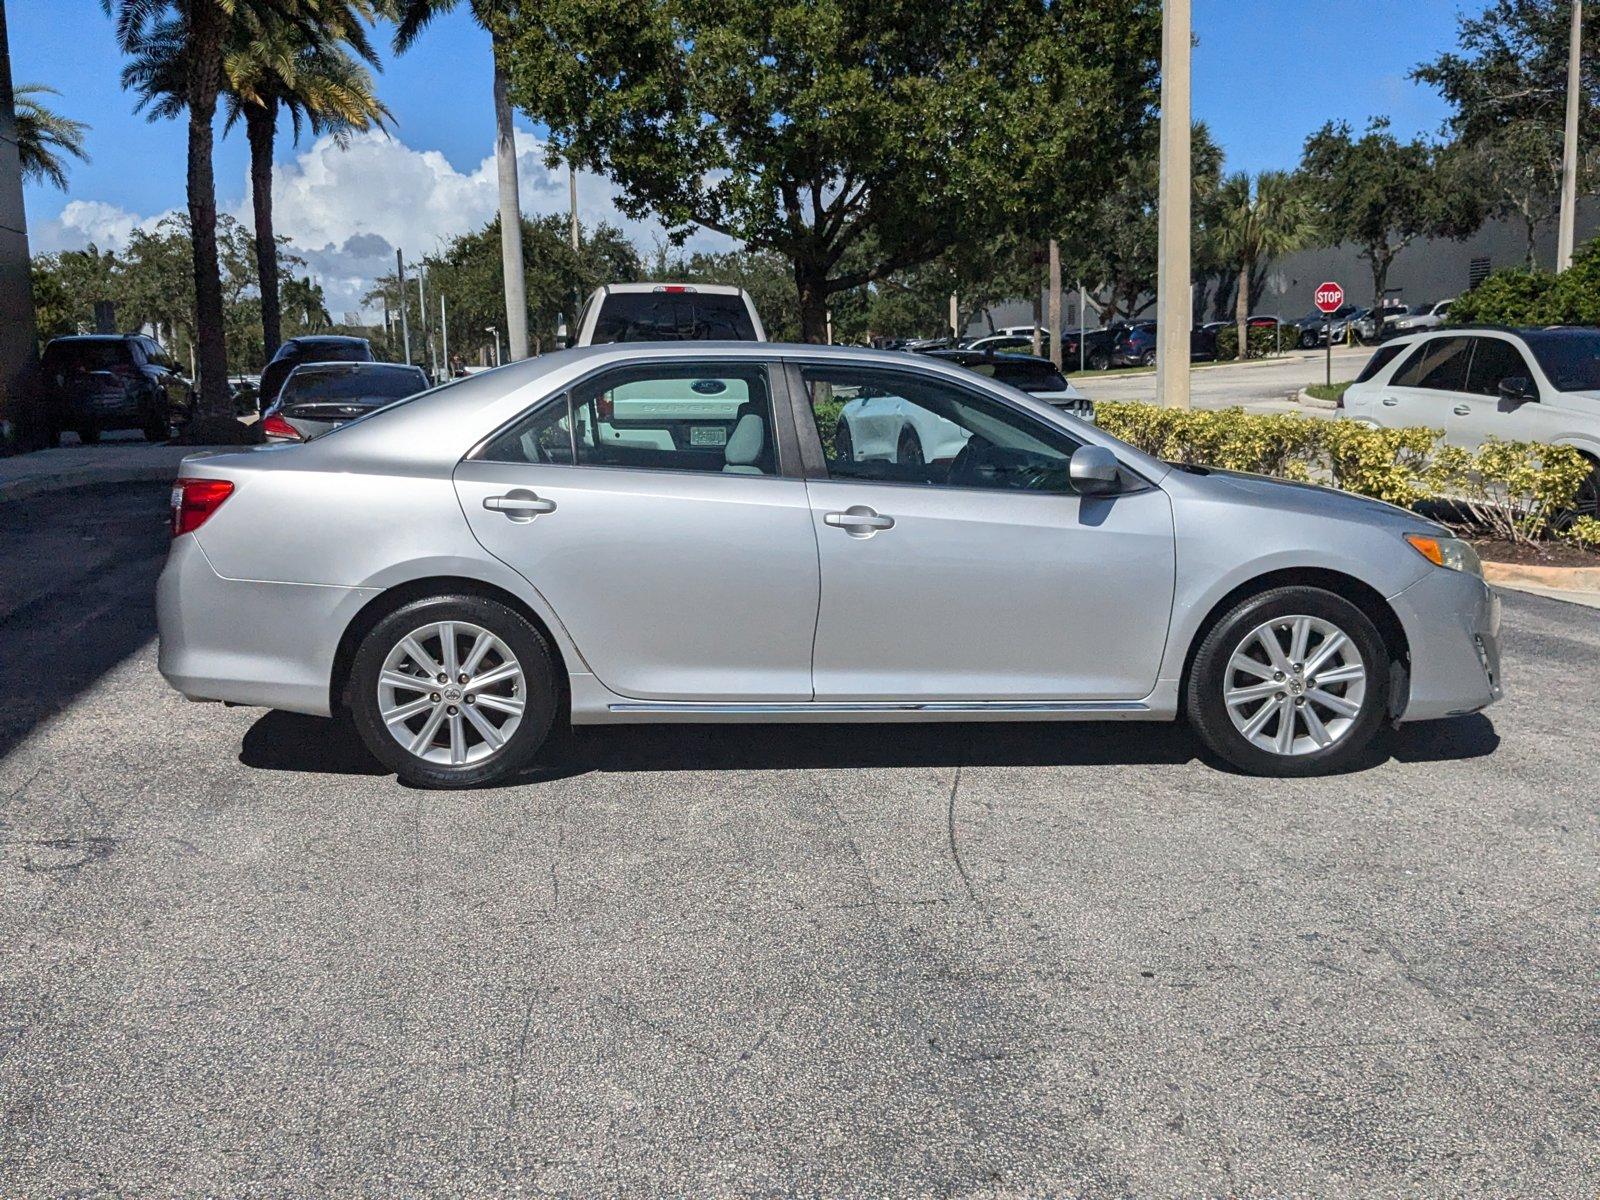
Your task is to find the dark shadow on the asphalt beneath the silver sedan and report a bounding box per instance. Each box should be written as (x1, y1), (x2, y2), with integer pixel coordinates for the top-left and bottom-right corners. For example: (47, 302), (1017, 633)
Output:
(238, 712), (1499, 787)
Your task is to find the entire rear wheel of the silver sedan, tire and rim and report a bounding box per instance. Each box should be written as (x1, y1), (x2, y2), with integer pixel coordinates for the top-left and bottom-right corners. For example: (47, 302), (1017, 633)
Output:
(347, 595), (558, 787)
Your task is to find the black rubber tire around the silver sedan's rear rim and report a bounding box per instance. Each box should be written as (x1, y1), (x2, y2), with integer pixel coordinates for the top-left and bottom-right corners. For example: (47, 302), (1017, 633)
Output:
(346, 595), (560, 789)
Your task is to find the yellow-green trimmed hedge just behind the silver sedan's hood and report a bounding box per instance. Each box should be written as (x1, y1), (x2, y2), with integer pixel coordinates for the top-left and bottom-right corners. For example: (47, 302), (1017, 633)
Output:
(1094, 402), (1590, 542)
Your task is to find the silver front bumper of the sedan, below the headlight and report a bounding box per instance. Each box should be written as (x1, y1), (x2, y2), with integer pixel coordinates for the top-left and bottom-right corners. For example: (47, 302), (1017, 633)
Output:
(1389, 568), (1506, 722)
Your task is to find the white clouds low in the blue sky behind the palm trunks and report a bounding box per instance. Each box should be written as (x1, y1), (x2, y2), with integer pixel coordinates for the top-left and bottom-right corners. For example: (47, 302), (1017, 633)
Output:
(32, 130), (731, 318)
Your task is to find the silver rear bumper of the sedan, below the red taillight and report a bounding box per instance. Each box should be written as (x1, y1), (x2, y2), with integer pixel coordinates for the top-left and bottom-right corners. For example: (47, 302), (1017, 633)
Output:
(155, 534), (378, 717)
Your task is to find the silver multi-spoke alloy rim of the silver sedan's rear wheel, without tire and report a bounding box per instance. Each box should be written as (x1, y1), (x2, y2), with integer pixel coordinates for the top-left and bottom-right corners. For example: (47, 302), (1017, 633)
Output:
(378, 621), (526, 766)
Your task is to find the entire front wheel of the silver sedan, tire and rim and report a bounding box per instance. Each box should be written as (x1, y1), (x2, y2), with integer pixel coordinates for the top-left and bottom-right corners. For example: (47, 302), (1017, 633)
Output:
(1184, 587), (1389, 776)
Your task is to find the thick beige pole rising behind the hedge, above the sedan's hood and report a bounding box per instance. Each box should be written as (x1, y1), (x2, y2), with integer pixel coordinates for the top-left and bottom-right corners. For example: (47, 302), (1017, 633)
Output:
(1155, 0), (1194, 408)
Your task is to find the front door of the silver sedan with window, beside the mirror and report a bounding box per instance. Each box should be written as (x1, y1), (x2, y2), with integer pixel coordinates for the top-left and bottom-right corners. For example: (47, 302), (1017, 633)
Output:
(790, 360), (1174, 702)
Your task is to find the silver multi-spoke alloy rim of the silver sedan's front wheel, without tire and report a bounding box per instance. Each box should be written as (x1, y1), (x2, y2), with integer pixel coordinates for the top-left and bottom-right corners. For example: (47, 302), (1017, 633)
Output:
(1222, 616), (1366, 755)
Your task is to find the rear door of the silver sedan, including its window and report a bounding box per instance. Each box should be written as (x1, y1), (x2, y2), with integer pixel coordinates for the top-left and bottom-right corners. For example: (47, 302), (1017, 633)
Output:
(454, 366), (818, 702)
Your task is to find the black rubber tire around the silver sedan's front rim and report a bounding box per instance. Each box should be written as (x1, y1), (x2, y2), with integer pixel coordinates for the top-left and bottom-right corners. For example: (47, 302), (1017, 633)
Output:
(1184, 587), (1390, 778)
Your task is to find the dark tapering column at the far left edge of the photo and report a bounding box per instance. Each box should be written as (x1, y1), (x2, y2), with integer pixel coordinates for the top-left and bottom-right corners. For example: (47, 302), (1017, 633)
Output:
(0, 0), (38, 448)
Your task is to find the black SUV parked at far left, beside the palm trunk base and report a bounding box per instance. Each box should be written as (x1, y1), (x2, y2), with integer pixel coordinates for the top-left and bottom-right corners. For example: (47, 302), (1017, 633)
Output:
(40, 333), (195, 445)
